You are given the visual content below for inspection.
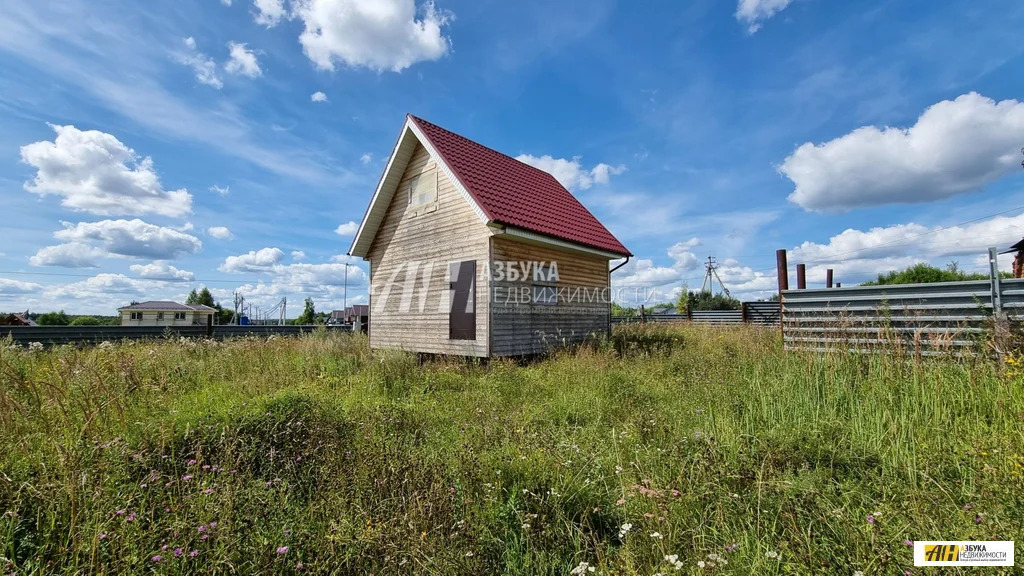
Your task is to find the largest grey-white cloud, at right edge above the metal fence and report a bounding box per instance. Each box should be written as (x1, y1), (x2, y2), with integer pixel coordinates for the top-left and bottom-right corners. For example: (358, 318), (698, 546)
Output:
(779, 92), (1024, 211)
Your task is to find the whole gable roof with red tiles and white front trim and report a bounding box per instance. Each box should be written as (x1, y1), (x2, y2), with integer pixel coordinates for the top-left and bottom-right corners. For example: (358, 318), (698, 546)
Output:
(349, 115), (632, 257)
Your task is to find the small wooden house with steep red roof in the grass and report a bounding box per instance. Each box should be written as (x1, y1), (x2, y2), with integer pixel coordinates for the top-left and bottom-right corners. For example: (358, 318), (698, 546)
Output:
(349, 116), (632, 357)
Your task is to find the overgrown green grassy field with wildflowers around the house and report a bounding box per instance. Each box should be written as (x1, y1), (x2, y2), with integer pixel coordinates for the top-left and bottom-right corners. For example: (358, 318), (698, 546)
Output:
(0, 327), (1024, 576)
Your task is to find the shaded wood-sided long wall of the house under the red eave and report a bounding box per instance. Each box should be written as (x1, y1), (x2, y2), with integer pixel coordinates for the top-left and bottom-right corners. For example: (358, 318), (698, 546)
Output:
(490, 236), (611, 356)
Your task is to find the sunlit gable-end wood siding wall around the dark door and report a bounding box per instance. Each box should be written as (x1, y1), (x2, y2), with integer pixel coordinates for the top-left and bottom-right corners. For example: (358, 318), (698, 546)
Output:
(367, 145), (490, 357)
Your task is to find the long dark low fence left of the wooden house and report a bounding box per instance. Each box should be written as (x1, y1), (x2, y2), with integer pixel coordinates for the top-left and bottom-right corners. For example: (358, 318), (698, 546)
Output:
(0, 325), (350, 345)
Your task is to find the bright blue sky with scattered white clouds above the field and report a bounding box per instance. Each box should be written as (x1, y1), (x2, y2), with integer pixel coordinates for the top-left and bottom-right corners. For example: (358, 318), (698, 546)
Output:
(0, 0), (1024, 316)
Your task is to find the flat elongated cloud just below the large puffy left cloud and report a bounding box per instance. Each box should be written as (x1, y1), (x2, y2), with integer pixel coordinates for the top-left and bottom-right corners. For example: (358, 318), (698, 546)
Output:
(47, 218), (203, 260)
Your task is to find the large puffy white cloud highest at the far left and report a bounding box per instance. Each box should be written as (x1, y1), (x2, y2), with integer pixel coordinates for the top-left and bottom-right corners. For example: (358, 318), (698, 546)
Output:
(22, 124), (191, 217)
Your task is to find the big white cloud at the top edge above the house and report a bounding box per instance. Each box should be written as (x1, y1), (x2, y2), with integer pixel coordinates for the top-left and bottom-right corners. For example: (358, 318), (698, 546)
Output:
(292, 0), (453, 72)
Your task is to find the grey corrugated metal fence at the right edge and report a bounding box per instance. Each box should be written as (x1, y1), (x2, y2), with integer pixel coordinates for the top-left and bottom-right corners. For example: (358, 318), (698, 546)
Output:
(782, 279), (1024, 355)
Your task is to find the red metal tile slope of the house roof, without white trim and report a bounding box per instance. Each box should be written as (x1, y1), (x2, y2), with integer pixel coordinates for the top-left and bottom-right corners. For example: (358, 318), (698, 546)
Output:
(410, 115), (633, 256)
